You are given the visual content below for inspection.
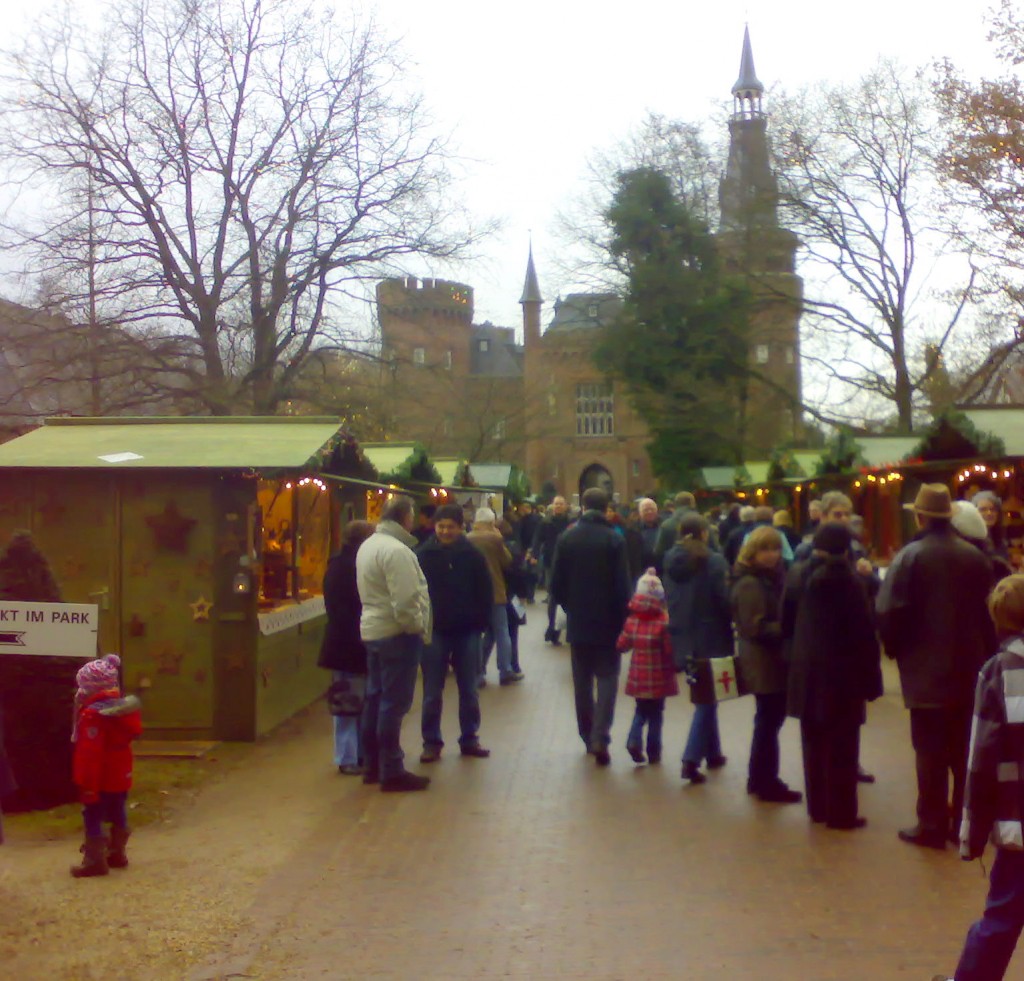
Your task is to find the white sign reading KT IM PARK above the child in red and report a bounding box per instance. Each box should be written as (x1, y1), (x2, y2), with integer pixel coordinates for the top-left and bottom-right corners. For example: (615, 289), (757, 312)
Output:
(0, 600), (99, 657)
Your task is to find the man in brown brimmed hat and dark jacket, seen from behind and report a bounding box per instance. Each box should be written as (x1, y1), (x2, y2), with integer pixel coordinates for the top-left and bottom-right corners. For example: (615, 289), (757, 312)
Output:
(877, 483), (995, 849)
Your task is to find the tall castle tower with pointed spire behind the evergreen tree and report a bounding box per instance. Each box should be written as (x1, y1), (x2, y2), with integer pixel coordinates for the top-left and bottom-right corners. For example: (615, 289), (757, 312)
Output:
(718, 29), (803, 460)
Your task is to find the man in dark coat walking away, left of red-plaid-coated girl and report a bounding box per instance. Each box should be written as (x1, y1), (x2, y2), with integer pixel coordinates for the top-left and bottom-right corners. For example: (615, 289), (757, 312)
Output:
(551, 487), (632, 766)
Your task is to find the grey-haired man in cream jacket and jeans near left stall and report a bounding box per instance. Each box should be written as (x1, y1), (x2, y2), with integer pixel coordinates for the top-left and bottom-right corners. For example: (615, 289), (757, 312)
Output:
(355, 497), (430, 793)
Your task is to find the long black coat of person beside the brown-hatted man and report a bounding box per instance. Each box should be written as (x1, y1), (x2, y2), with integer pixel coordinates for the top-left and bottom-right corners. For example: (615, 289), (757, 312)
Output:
(782, 556), (882, 726)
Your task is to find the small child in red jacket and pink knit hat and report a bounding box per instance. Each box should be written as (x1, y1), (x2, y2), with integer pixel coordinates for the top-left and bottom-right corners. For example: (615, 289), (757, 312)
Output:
(71, 654), (142, 879)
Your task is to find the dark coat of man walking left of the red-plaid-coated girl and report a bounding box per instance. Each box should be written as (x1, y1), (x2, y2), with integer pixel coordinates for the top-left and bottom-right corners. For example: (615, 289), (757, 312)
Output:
(551, 511), (633, 650)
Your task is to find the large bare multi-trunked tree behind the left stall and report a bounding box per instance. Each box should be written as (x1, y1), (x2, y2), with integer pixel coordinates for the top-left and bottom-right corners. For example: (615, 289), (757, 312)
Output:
(0, 0), (474, 414)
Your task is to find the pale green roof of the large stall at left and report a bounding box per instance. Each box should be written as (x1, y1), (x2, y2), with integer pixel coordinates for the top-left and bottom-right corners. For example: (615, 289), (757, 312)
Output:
(0, 416), (341, 470)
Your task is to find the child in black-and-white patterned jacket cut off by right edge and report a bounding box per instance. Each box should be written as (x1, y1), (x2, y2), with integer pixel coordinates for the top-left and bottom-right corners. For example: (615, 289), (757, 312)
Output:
(939, 573), (1024, 981)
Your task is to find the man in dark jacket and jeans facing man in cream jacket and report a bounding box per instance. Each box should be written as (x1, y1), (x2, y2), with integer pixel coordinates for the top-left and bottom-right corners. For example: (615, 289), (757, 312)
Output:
(416, 504), (495, 763)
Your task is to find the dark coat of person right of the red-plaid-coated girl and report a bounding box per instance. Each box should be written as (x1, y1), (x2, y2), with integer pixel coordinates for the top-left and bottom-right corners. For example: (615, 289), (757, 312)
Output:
(663, 544), (734, 671)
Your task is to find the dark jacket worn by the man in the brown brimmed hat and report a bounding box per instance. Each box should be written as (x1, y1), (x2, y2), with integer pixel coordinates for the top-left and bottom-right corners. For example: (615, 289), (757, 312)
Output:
(876, 524), (995, 709)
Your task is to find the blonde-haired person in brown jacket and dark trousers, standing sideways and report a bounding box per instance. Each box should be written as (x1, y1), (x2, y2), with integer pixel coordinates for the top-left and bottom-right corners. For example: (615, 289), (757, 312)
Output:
(731, 527), (803, 804)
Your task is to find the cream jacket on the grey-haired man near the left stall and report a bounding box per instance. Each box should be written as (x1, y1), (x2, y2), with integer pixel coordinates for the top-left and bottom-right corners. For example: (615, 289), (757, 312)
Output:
(355, 521), (431, 641)
